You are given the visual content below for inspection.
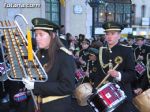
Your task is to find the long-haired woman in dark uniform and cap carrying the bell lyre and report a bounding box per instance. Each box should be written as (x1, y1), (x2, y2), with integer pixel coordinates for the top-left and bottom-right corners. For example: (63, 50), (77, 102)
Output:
(23, 18), (75, 112)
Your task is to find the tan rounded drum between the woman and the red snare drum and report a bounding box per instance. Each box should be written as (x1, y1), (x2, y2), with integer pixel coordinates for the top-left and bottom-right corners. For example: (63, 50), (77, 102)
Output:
(74, 82), (93, 106)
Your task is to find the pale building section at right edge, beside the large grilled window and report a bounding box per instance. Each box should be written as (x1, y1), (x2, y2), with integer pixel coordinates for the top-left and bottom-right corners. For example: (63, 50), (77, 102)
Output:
(132, 0), (150, 38)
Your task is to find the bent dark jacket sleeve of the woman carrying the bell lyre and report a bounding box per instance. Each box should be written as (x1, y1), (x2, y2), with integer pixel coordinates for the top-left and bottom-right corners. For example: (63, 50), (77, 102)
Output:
(34, 53), (75, 96)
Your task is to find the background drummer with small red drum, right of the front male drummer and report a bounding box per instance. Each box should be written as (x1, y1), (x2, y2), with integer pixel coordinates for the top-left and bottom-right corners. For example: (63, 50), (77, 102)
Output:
(134, 36), (150, 95)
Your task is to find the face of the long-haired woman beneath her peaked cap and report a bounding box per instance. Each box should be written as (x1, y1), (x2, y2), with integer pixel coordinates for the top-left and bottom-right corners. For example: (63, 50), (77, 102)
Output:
(35, 30), (51, 49)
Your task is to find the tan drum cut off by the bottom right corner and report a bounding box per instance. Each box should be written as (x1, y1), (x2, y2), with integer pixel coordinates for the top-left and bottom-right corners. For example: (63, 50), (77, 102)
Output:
(133, 89), (150, 112)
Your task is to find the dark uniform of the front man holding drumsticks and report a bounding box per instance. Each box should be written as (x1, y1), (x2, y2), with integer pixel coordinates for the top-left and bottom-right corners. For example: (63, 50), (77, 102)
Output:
(95, 44), (136, 112)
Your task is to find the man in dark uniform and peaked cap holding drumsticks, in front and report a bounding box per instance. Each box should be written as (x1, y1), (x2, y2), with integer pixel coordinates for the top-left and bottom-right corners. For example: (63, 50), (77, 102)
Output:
(94, 22), (136, 112)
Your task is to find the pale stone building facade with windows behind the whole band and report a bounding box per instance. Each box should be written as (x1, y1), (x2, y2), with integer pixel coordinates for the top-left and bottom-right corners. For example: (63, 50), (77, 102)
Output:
(0, 0), (150, 38)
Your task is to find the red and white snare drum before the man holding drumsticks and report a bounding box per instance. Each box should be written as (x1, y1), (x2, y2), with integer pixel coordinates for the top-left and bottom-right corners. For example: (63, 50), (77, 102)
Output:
(88, 83), (126, 112)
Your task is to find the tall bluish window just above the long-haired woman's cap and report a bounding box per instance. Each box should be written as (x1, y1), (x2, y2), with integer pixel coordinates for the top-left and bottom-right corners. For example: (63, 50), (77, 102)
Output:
(45, 0), (60, 24)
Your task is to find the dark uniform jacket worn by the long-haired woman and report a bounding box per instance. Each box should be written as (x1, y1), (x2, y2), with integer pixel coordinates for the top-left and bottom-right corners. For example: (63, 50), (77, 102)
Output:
(29, 50), (75, 112)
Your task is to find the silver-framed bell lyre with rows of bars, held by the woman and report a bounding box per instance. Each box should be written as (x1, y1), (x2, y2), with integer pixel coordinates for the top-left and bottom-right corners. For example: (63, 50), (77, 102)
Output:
(0, 14), (48, 110)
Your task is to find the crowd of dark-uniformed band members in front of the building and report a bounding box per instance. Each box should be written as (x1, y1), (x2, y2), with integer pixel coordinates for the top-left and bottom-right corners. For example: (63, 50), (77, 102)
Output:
(0, 18), (150, 112)
